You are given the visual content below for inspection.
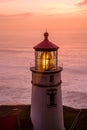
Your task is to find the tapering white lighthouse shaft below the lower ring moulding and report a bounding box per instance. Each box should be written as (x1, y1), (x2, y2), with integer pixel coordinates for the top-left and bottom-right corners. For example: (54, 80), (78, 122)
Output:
(31, 87), (64, 130)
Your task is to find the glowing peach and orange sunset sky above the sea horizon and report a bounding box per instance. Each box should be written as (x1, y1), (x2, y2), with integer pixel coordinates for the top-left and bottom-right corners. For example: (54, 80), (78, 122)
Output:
(0, 0), (87, 30)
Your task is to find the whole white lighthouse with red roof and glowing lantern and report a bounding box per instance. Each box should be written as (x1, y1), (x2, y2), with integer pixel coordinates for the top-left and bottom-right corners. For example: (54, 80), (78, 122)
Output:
(30, 32), (64, 130)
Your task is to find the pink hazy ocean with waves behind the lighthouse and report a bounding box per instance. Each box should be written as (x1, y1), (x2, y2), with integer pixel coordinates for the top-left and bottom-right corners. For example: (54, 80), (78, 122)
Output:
(0, 30), (87, 108)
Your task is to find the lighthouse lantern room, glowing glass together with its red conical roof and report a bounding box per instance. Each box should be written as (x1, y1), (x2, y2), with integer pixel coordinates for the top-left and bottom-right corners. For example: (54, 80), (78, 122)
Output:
(34, 32), (59, 71)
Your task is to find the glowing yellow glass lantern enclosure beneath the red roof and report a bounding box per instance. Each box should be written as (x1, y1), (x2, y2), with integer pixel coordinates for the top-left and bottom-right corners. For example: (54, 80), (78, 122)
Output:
(35, 51), (57, 71)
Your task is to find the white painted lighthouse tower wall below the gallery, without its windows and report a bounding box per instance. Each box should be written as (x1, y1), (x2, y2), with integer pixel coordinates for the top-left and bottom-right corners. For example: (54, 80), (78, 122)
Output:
(31, 72), (64, 130)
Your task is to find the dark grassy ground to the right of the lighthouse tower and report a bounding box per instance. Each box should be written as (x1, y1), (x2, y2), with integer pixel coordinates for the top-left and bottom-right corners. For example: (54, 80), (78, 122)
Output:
(63, 106), (87, 130)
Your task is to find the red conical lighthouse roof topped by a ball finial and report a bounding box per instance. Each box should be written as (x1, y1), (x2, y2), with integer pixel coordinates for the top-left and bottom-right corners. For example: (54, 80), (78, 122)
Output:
(34, 32), (59, 51)
